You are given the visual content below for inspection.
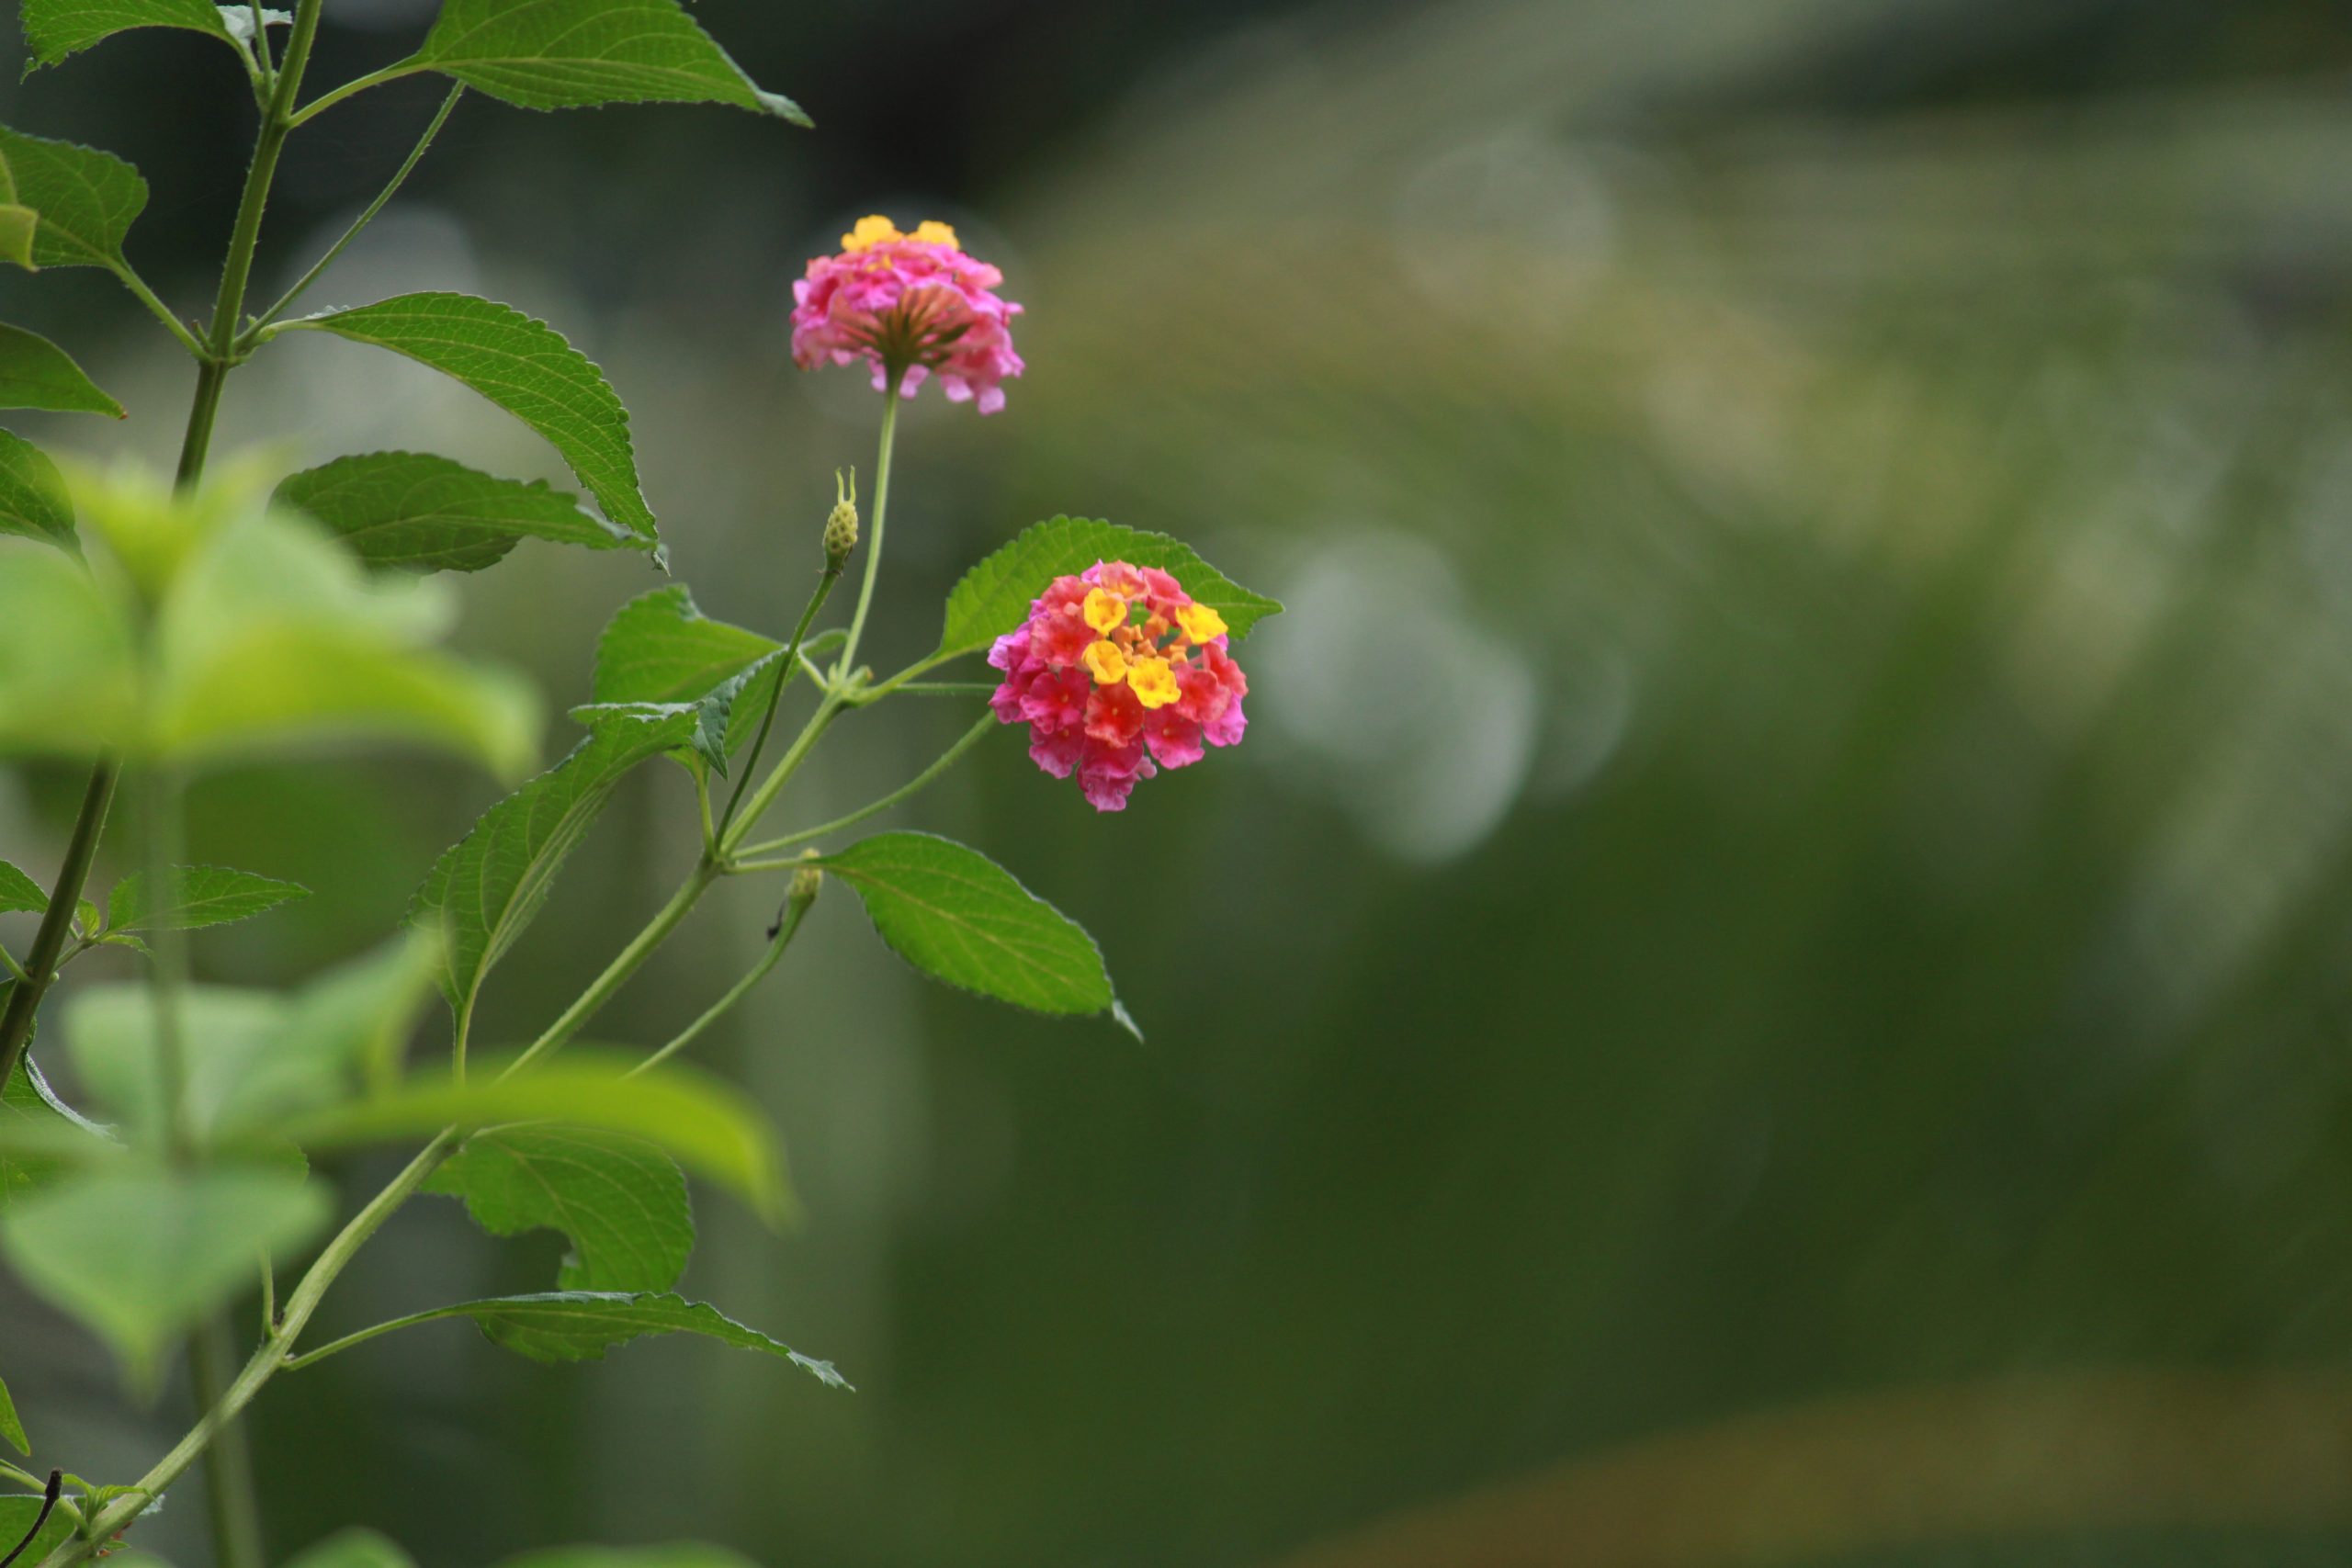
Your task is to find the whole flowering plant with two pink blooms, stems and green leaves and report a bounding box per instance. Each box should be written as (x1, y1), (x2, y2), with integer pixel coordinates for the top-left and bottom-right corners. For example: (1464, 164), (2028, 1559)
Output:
(0, 0), (1280, 1568)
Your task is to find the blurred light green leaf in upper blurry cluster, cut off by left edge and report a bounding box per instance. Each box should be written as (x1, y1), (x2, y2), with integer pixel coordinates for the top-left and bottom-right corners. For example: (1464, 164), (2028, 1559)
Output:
(0, 536), (136, 757)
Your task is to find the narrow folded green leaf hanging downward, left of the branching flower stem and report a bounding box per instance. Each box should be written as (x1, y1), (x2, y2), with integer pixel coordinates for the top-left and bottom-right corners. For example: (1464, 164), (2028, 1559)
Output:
(409, 710), (694, 1016)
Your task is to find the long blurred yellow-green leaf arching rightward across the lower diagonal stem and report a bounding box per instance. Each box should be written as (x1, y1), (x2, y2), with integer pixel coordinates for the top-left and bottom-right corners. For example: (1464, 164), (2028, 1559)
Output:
(277, 1046), (788, 1223)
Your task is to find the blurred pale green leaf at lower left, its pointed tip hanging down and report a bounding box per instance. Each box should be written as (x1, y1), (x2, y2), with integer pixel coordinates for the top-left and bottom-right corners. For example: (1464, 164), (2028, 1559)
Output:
(0, 1166), (332, 1384)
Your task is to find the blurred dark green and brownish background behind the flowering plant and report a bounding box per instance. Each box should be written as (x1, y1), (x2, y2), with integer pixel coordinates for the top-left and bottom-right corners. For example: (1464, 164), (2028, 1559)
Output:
(0, 0), (2352, 1568)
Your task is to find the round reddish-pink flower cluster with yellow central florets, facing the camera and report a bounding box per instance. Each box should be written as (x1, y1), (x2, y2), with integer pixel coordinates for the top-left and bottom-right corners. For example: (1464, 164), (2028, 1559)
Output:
(988, 562), (1249, 811)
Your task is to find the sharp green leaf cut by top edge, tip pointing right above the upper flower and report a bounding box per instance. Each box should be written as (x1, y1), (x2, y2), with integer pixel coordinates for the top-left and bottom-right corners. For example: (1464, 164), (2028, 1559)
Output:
(414, 0), (809, 125)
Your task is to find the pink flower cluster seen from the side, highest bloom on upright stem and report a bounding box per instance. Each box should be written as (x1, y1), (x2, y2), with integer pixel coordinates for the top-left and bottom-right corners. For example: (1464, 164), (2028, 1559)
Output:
(793, 216), (1023, 413)
